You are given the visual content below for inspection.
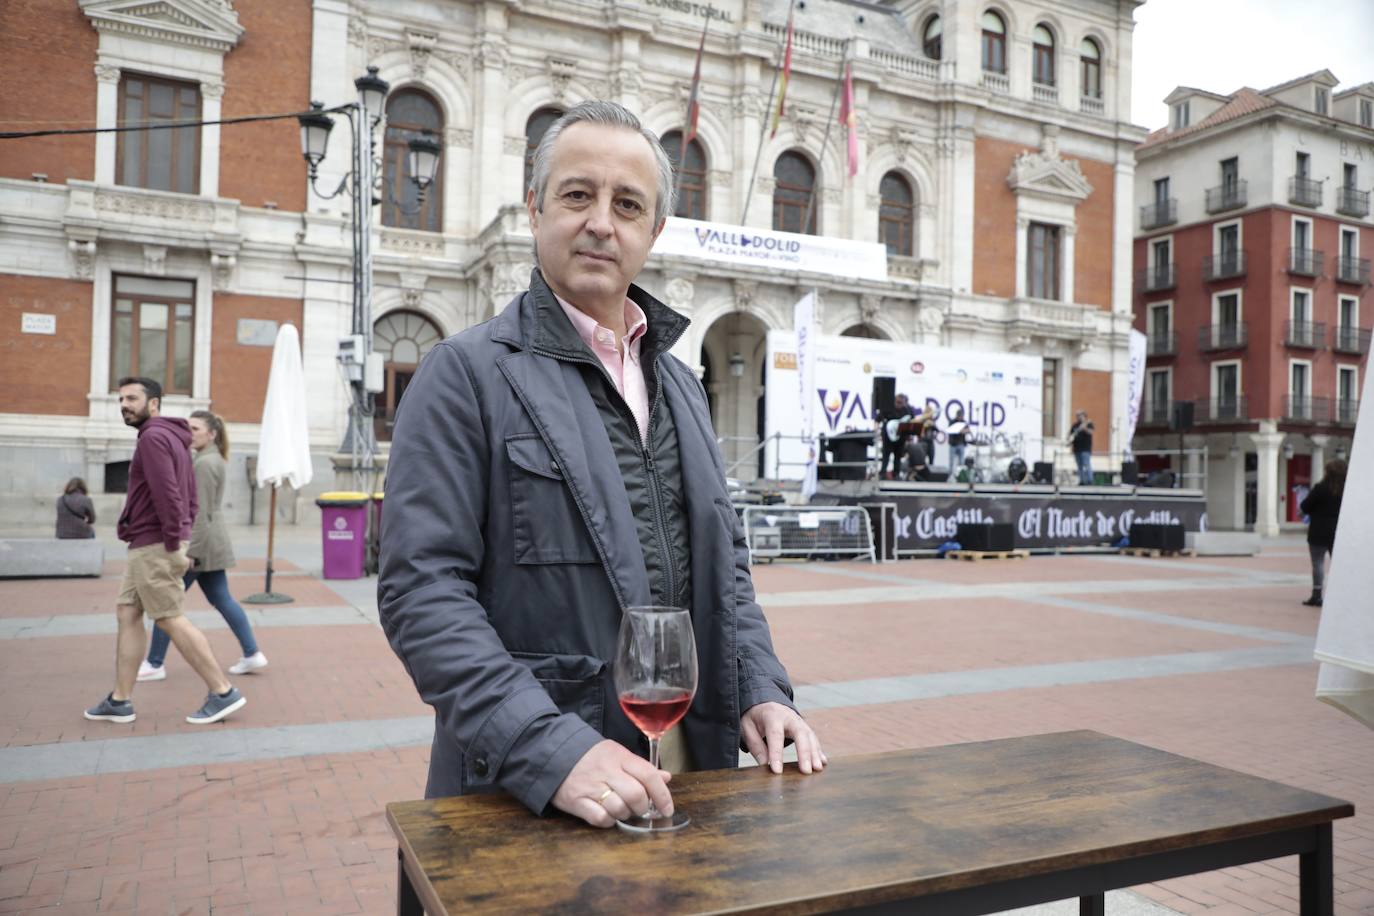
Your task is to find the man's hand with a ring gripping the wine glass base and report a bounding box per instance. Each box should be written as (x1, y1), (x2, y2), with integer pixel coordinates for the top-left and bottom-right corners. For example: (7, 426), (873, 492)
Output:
(554, 729), (673, 827)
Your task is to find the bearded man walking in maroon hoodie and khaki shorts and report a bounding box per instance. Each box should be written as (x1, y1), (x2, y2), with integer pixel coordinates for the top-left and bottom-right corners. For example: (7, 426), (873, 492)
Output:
(85, 378), (247, 725)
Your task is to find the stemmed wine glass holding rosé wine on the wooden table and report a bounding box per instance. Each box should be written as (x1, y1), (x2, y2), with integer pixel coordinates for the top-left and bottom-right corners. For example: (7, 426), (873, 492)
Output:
(614, 607), (697, 834)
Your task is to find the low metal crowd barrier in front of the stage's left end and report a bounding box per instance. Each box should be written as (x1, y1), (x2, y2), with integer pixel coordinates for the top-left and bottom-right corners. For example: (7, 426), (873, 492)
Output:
(742, 505), (878, 563)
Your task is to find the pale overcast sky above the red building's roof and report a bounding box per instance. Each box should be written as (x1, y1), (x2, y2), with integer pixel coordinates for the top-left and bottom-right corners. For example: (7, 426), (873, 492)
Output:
(1131, 0), (1374, 130)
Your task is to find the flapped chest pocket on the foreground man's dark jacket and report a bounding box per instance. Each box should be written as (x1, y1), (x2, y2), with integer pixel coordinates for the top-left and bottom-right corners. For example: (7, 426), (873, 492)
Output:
(506, 433), (596, 563)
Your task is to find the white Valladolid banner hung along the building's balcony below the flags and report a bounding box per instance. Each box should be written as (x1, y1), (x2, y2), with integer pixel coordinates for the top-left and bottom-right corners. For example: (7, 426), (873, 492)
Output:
(654, 217), (888, 280)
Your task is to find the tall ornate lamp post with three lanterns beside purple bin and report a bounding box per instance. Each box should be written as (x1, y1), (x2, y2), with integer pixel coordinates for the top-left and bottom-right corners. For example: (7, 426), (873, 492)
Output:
(297, 66), (442, 573)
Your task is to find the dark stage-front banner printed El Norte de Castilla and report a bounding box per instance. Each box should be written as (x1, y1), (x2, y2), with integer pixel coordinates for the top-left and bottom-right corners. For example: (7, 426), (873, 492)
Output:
(841, 492), (1206, 556)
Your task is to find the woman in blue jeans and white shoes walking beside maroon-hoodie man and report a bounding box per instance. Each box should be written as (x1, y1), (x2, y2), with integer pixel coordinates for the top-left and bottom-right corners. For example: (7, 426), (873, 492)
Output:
(139, 411), (267, 681)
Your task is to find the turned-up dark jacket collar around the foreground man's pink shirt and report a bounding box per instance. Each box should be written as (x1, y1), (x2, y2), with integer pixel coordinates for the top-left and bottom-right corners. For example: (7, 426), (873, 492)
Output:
(492, 268), (691, 363)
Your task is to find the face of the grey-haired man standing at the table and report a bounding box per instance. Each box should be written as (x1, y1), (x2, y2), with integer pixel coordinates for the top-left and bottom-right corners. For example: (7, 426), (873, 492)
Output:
(525, 122), (664, 310)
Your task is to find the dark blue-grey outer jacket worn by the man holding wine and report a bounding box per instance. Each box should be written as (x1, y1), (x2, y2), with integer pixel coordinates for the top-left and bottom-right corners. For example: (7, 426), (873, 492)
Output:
(378, 271), (791, 813)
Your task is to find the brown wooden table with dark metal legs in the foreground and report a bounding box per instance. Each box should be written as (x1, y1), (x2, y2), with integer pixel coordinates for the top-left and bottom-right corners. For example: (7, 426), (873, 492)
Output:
(386, 731), (1355, 916)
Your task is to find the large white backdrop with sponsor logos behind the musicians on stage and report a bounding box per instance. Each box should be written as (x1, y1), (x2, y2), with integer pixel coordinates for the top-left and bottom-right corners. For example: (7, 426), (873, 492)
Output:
(764, 331), (1043, 479)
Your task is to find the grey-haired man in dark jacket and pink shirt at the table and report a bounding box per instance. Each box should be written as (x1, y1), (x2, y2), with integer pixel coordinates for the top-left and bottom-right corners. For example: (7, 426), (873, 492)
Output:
(378, 102), (826, 827)
